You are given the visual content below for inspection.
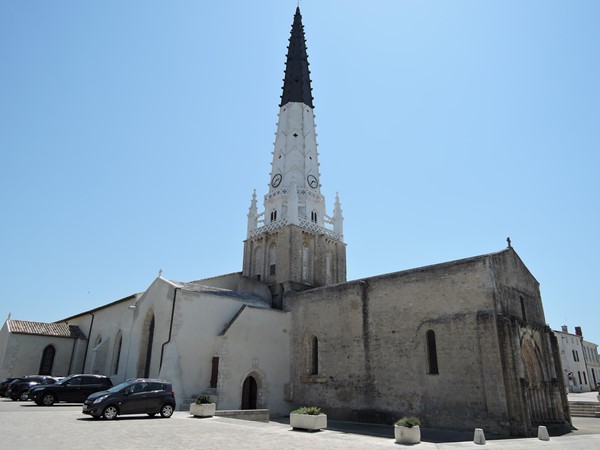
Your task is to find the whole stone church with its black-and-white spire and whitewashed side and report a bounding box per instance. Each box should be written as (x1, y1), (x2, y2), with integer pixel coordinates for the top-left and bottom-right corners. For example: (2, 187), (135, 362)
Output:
(0, 8), (570, 436)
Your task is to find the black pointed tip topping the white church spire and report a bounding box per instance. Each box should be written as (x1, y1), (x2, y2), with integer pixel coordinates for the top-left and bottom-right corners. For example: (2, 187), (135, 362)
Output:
(279, 7), (314, 108)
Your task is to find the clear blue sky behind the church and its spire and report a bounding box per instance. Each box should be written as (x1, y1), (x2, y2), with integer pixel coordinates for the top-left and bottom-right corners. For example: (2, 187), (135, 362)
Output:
(0, 0), (600, 343)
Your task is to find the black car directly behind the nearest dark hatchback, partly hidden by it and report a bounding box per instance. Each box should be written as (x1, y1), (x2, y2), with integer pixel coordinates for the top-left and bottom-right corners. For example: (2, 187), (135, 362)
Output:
(29, 374), (112, 406)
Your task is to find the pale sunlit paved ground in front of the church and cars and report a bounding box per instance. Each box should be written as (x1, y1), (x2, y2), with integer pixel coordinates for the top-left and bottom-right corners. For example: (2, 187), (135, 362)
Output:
(0, 393), (600, 450)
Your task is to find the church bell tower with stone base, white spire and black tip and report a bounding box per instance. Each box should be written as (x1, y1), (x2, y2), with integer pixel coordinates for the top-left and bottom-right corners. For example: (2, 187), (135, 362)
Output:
(242, 8), (346, 307)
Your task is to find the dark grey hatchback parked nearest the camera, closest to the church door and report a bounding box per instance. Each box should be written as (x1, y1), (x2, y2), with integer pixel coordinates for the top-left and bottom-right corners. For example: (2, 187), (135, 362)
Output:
(82, 378), (175, 420)
